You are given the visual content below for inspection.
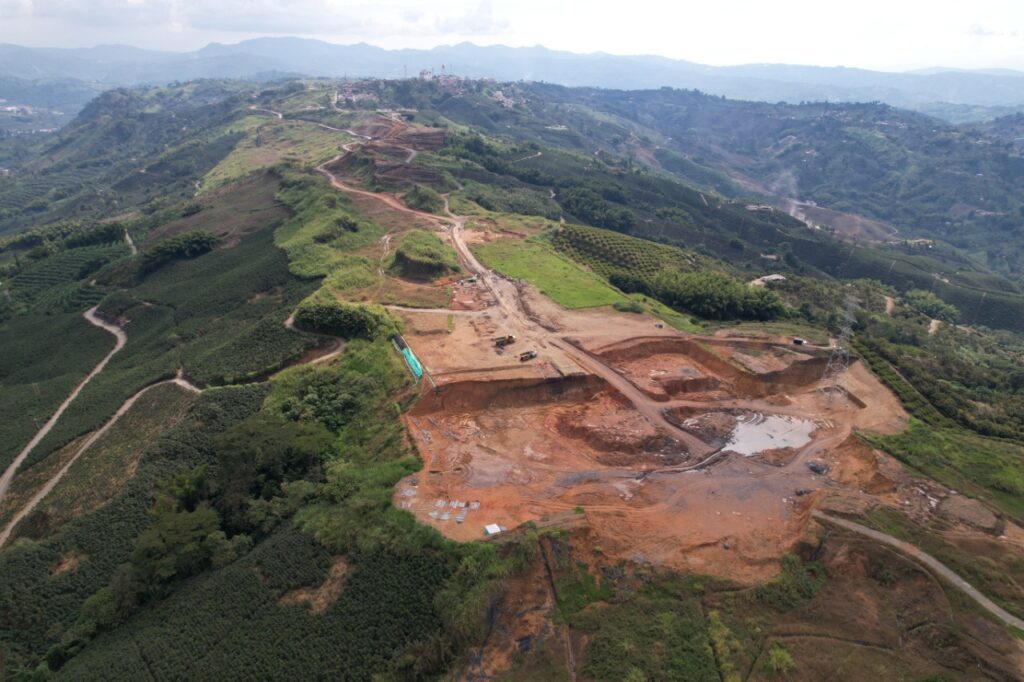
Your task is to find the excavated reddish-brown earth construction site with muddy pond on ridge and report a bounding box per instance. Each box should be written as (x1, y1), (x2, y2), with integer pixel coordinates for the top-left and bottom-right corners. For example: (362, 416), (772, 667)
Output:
(322, 111), (906, 582)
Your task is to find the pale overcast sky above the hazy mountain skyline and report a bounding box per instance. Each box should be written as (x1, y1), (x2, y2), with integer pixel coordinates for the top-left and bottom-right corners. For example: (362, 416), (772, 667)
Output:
(0, 0), (1024, 71)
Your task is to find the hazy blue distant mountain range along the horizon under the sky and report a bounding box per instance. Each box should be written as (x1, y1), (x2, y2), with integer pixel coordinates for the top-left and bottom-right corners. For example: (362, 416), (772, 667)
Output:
(0, 38), (1024, 122)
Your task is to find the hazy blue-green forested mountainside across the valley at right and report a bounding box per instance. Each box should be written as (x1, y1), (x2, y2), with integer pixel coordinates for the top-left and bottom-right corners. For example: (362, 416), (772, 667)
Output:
(516, 87), (1024, 280)
